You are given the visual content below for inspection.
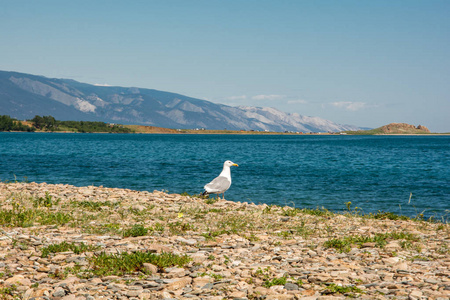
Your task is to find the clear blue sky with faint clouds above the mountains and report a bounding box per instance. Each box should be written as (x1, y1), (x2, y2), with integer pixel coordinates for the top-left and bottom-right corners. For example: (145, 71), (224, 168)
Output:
(0, 0), (450, 132)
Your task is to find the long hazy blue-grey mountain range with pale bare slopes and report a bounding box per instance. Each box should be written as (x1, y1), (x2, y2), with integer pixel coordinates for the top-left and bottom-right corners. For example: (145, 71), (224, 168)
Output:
(0, 71), (360, 132)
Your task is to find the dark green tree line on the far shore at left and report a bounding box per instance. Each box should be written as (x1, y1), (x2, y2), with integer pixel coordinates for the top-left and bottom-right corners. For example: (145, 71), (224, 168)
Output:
(0, 115), (133, 133)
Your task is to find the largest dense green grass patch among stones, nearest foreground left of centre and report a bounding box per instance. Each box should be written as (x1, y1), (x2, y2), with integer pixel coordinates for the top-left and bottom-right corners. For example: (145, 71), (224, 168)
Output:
(89, 252), (191, 276)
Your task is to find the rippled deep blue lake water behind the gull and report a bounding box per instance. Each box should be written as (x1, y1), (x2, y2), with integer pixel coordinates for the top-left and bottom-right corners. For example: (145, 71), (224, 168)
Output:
(0, 133), (450, 218)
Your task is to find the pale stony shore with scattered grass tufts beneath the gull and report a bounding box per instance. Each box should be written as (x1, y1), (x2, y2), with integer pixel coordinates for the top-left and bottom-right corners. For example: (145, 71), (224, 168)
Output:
(0, 183), (450, 300)
